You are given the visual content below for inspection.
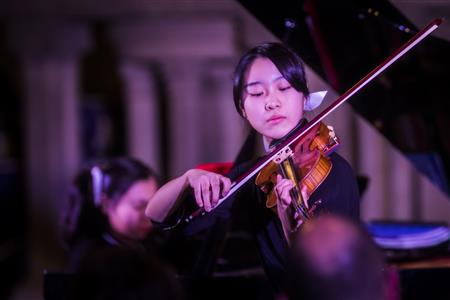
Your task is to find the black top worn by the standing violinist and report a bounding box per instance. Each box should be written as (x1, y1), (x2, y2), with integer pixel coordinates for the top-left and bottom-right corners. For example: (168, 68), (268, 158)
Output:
(160, 153), (359, 291)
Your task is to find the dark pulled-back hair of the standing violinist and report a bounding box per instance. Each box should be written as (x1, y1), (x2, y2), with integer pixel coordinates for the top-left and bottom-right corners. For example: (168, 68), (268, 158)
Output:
(233, 43), (309, 116)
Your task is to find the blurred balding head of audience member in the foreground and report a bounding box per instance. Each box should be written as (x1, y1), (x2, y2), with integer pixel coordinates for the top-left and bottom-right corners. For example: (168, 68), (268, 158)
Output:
(285, 214), (386, 300)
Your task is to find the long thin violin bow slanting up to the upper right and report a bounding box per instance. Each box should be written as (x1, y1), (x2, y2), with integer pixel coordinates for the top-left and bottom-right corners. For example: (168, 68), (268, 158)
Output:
(185, 18), (443, 222)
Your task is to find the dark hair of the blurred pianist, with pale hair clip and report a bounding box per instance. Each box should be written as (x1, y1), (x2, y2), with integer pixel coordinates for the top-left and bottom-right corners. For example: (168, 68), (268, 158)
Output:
(61, 157), (160, 248)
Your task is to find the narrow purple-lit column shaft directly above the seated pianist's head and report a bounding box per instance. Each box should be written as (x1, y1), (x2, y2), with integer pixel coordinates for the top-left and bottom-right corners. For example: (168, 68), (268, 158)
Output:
(121, 59), (162, 174)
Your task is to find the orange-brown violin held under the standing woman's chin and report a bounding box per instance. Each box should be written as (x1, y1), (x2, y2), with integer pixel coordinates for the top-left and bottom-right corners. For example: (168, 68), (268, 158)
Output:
(255, 122), (339, 221)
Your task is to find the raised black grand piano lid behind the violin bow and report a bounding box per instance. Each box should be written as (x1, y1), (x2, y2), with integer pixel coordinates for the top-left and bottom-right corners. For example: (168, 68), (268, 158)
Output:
(239, 0), (450, 194)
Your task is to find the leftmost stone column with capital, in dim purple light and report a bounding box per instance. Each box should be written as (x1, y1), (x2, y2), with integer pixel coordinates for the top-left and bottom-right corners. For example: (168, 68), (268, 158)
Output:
(8, 20), (89, 288)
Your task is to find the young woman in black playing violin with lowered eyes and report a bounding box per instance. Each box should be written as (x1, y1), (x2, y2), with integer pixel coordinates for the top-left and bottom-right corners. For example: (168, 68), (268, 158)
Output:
(146, 43), (359, 290)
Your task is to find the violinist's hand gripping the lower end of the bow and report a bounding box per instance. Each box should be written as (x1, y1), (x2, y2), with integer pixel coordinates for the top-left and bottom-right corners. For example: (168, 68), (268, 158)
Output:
(185, 169), (231, 212)
